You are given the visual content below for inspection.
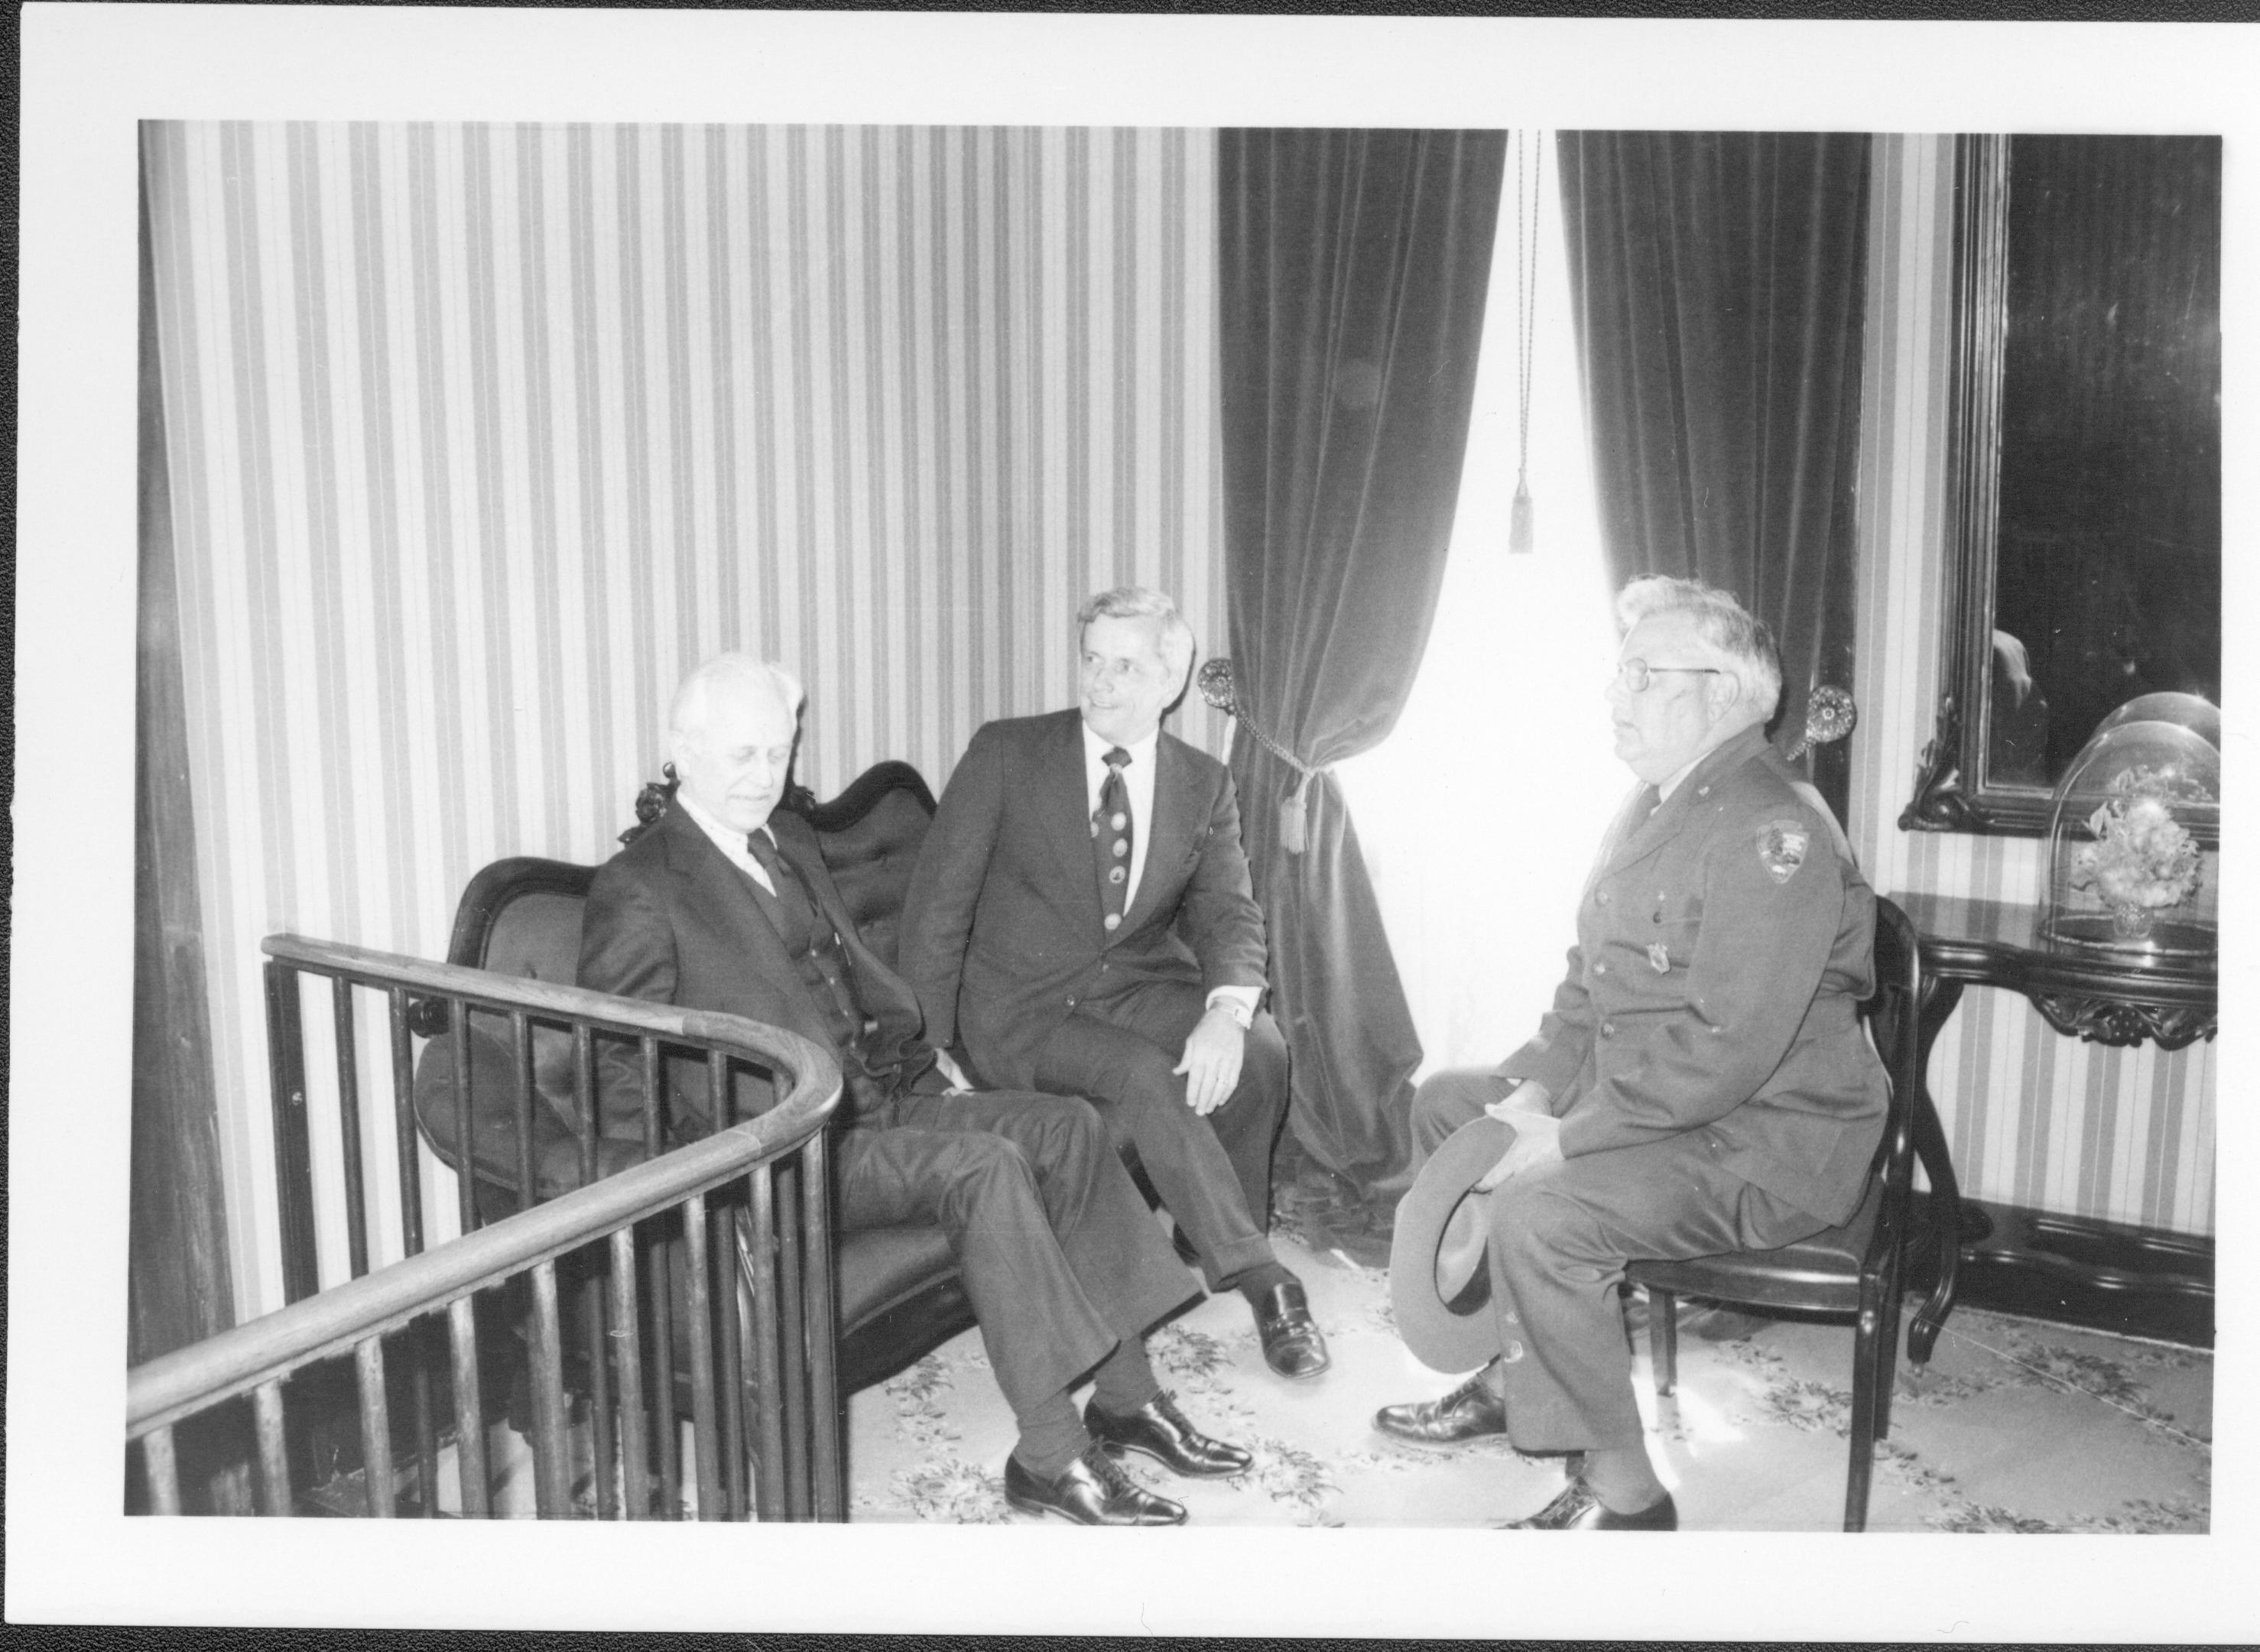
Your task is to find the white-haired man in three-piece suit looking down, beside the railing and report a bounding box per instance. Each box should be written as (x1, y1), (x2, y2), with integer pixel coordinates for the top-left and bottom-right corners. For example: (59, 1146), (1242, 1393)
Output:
(581, 653), (1250, 1525)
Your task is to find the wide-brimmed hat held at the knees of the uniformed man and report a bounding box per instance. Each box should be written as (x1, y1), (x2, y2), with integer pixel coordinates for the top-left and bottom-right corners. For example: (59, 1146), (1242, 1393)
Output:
(1390, 1114), (1515, 1371)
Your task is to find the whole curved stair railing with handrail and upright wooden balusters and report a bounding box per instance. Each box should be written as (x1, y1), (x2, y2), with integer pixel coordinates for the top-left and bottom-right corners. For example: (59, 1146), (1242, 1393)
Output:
(127, 936), (843, 1519)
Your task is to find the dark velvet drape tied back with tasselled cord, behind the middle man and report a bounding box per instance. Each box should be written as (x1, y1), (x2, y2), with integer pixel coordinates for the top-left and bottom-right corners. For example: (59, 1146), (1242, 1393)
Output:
(1218, 131), (1505, 1189)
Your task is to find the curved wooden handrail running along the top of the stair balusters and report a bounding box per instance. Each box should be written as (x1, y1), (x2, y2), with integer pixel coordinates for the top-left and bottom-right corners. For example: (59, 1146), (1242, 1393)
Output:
(127, 936), (841, 1439)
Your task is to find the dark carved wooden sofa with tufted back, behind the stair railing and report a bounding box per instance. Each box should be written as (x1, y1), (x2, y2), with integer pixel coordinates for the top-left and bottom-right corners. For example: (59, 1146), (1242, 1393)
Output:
(416, 761), (974, 1394)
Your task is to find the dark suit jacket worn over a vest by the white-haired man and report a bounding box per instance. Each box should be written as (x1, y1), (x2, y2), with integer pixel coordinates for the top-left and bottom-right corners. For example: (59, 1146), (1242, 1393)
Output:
(581, 809), (943, 1141)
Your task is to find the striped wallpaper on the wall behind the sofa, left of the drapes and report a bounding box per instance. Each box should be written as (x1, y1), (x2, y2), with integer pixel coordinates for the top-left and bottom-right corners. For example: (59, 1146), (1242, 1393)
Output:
(144, 125), (1227, 1313)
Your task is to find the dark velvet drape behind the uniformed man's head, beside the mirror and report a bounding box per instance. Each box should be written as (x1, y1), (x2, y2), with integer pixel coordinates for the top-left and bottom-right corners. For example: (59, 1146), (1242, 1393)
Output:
(1560, 131), (1869, 818)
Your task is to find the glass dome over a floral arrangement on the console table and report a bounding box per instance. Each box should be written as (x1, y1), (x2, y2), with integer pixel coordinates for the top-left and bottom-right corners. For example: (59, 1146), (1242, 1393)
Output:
(2043, 719), (2222, 962)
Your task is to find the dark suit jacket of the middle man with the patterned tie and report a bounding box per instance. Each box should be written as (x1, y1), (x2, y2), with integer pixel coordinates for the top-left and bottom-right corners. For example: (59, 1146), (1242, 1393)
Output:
(899, 712), (1263, 1089)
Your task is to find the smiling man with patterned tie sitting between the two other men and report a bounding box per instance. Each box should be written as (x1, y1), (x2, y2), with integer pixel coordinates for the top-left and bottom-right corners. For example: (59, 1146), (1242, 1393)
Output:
(901, 586), (1329, 1378)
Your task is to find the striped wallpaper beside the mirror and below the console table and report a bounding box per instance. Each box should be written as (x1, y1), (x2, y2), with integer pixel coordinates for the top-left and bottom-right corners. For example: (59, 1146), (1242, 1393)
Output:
(1851, 135), (2217, 1234)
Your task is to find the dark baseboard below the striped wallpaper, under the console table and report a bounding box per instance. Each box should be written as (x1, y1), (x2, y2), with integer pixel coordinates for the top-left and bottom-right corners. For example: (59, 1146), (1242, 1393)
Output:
(1955, 1200), (2213, 1347)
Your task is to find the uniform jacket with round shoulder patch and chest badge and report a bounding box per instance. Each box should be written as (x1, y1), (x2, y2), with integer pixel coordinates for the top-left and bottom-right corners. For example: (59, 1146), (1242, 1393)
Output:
(1499, 730), (1889, 1222)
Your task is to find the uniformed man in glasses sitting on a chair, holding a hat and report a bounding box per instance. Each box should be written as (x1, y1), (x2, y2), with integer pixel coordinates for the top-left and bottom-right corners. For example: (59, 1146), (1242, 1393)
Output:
(1374, 579), (1887, 1530)
